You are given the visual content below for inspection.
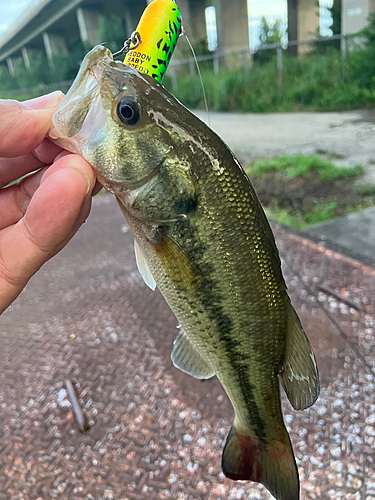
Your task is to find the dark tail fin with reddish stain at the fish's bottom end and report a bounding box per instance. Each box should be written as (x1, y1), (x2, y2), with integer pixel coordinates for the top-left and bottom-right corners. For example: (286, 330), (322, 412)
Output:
(222, 426), (299, 500)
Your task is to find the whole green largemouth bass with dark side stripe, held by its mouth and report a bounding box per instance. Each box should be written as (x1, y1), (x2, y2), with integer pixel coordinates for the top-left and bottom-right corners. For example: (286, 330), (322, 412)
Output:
(49, 45), (319, 500)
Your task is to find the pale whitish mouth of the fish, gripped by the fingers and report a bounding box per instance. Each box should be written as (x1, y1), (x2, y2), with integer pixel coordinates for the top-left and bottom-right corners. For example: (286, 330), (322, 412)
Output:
(49, 45), (114, 148)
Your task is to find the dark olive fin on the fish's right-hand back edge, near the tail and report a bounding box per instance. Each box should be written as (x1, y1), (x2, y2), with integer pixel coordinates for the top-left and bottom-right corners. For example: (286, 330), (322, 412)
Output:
(280, 306), (319, 410)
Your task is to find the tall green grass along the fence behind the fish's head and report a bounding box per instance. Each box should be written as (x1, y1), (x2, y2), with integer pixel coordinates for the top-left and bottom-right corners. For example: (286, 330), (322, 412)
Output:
(164, 45), (375, 113)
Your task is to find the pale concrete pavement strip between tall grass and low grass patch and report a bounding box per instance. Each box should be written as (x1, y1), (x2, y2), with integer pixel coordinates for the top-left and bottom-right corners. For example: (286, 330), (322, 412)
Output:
(196, 110), (375, 184)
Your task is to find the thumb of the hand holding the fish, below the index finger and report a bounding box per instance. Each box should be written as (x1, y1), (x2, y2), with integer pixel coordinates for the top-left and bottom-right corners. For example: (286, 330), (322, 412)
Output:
(0, 155), (95, 314)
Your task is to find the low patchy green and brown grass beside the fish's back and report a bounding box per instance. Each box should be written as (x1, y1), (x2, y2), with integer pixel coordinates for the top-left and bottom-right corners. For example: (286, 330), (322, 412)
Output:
(246, 155), (375, 229)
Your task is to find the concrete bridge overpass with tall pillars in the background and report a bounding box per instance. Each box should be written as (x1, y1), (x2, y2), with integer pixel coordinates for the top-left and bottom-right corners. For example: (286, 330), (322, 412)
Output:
(0, 0), (375, 73)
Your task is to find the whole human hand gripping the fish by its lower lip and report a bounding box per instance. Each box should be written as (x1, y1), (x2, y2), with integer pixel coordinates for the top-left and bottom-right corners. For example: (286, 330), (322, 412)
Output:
(0, 92), (96, 314)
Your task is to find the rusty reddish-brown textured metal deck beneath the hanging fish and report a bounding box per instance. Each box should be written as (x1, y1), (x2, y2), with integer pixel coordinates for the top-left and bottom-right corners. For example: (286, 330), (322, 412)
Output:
(0, 196), (375, 500)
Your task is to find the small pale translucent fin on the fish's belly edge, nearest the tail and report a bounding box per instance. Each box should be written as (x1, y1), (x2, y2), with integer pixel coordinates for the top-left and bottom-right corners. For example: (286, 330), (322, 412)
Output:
(171, 330), (215, 379)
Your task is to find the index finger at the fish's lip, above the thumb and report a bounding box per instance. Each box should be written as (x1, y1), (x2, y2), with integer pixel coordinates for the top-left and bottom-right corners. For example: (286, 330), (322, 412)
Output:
(0, 91), (63, 158)
